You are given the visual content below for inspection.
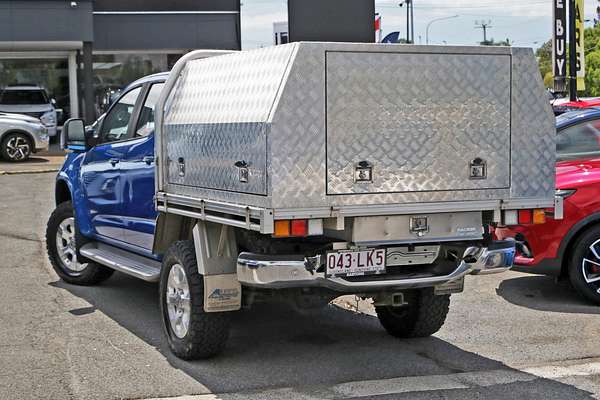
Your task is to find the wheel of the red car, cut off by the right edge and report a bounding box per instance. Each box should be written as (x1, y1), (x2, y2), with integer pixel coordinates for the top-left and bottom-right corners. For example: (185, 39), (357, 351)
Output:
(568, 226), (600, 304)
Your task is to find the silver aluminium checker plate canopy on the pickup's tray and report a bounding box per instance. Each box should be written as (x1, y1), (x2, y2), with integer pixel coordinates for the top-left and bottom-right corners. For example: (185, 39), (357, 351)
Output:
(157, 42), (555, 223)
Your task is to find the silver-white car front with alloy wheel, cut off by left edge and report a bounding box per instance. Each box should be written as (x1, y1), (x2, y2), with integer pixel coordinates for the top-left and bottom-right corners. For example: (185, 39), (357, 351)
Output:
(0, 113), (49, 162)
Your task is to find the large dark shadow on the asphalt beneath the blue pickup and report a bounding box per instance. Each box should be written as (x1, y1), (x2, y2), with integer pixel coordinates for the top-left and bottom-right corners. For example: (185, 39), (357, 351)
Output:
(51, 273), (591, 399)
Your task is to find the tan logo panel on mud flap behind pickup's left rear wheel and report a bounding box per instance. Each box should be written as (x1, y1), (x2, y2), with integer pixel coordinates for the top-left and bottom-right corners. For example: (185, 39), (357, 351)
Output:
(204, 274), (242, 312)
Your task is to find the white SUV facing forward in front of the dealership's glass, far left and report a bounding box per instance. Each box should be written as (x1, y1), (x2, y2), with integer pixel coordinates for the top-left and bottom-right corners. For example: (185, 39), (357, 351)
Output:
(0, 85), (57, 137)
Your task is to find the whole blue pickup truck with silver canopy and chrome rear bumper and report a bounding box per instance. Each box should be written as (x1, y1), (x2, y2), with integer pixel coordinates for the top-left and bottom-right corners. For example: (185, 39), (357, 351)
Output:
(46, 43), (540, 359)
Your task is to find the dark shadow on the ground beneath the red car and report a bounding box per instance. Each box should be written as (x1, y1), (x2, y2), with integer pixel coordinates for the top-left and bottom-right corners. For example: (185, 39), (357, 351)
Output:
(496, 275), (600, 314)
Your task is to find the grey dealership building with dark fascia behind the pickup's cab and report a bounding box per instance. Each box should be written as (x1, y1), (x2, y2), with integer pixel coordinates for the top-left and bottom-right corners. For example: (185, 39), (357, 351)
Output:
(0, 0), (241, 121)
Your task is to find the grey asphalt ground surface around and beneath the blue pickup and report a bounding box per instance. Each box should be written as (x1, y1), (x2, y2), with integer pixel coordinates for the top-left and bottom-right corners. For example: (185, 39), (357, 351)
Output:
(0, 174), (600, 400)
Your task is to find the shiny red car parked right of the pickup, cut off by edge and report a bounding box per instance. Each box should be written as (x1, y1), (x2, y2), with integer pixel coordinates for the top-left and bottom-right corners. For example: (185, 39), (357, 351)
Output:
(495, 109), (600, 304)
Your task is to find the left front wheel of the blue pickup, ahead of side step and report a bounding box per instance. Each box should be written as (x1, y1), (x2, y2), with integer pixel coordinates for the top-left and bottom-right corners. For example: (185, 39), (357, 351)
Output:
(46, 201), (114, 286)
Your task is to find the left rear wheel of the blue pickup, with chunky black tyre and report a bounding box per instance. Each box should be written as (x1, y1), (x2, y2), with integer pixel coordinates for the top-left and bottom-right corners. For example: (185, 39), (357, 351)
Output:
(160, 241), (230, 360)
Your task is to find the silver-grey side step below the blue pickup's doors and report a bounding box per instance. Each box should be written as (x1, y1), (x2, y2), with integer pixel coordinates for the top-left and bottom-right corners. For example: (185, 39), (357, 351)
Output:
(79, 242), (161, 282)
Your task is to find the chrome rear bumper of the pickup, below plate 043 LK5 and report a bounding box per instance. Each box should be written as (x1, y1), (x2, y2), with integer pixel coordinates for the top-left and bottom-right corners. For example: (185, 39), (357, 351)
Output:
(237, 241), (515, 292)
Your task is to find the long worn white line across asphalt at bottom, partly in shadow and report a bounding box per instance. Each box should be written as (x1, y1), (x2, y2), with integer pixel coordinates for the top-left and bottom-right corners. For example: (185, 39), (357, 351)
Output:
(146, 361), (600, 400)
